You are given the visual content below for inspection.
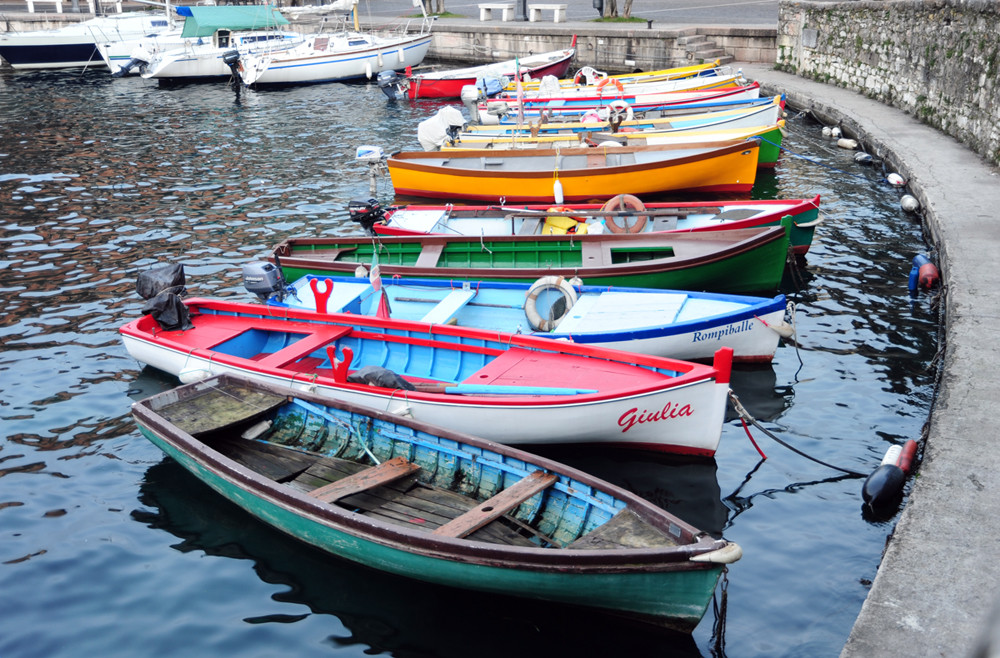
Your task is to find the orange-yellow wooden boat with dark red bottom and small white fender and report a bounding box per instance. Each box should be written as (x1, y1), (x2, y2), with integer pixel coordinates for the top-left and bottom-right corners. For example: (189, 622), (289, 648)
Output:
(386, 141), (760, 203)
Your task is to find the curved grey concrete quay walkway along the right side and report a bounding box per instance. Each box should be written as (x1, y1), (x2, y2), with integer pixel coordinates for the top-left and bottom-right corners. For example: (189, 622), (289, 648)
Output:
(733, 63), (1000, 658)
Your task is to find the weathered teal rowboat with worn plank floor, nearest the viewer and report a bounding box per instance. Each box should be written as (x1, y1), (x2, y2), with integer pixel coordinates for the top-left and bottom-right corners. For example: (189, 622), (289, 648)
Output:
(132, 376), (742, 631)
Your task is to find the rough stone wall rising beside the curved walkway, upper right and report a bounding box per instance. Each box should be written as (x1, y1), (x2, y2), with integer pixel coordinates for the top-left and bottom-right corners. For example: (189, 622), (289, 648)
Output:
(776, 0), (1000, 164)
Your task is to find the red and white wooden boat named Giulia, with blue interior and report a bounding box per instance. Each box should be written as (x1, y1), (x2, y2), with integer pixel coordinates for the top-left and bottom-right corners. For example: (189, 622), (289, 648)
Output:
(120, 299), (732, 456)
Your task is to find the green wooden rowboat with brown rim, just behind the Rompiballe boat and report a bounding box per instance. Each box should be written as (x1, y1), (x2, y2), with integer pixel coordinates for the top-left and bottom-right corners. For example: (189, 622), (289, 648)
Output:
(271, 219), (789, 293)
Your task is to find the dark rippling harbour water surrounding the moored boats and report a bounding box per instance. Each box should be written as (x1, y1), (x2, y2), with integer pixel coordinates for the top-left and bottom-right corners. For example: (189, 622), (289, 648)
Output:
(0, 69), (937, 658)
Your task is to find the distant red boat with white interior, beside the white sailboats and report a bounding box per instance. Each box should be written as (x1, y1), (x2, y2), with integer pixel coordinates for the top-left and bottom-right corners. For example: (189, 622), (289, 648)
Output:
(380, 35), (576, 100)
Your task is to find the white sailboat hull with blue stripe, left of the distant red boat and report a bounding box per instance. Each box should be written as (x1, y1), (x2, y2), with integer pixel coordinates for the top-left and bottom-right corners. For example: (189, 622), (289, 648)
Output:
(241, 34), (431, 85)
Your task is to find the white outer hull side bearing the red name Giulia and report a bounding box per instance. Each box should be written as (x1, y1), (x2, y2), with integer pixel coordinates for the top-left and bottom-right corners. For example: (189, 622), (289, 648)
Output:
(122, 335), (729, 455)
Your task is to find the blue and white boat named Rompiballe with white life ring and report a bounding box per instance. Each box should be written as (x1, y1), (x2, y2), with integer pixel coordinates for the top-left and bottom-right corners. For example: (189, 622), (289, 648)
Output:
(252, 263), (791, 363)
